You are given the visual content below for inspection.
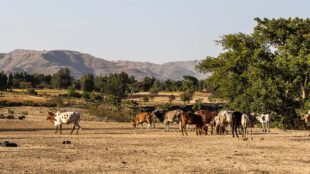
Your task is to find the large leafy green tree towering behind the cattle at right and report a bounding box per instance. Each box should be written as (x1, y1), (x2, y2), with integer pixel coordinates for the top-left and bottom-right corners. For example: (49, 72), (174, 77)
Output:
(197, 18), (310, 128)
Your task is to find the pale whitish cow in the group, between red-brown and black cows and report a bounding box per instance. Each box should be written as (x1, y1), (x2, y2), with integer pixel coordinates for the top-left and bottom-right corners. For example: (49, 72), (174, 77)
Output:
(218, 110), (234, 134)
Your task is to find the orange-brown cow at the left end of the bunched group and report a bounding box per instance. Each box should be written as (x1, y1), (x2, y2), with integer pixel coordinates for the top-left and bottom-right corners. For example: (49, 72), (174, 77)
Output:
(133, 112), (153, 132)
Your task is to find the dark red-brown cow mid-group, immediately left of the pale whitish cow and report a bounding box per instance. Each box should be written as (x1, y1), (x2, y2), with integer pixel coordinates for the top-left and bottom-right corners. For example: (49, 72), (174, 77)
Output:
(195, 110), (218, 135)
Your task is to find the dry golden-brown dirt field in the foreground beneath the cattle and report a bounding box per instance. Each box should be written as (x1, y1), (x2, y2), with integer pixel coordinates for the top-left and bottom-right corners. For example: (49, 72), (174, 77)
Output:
(0, 108), (310, 174)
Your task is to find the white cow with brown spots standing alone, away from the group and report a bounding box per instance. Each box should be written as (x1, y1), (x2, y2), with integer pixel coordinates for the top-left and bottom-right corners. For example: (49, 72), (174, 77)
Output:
(46, 111), (82, 135)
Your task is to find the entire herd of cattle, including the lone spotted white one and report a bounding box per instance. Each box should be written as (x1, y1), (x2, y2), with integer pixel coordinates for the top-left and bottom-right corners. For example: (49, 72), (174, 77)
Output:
(47, 109), (310, 138)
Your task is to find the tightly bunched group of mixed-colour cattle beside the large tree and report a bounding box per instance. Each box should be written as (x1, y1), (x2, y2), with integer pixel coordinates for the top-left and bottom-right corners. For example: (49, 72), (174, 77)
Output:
(133, 109), (270, 137)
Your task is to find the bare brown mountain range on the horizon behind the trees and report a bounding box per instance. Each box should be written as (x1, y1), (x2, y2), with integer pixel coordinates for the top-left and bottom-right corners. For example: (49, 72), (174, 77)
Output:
(0, 49), (207, 80)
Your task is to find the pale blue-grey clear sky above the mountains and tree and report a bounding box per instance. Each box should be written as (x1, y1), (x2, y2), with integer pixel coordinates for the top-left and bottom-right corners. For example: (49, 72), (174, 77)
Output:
(0, 0), (310, 64)
